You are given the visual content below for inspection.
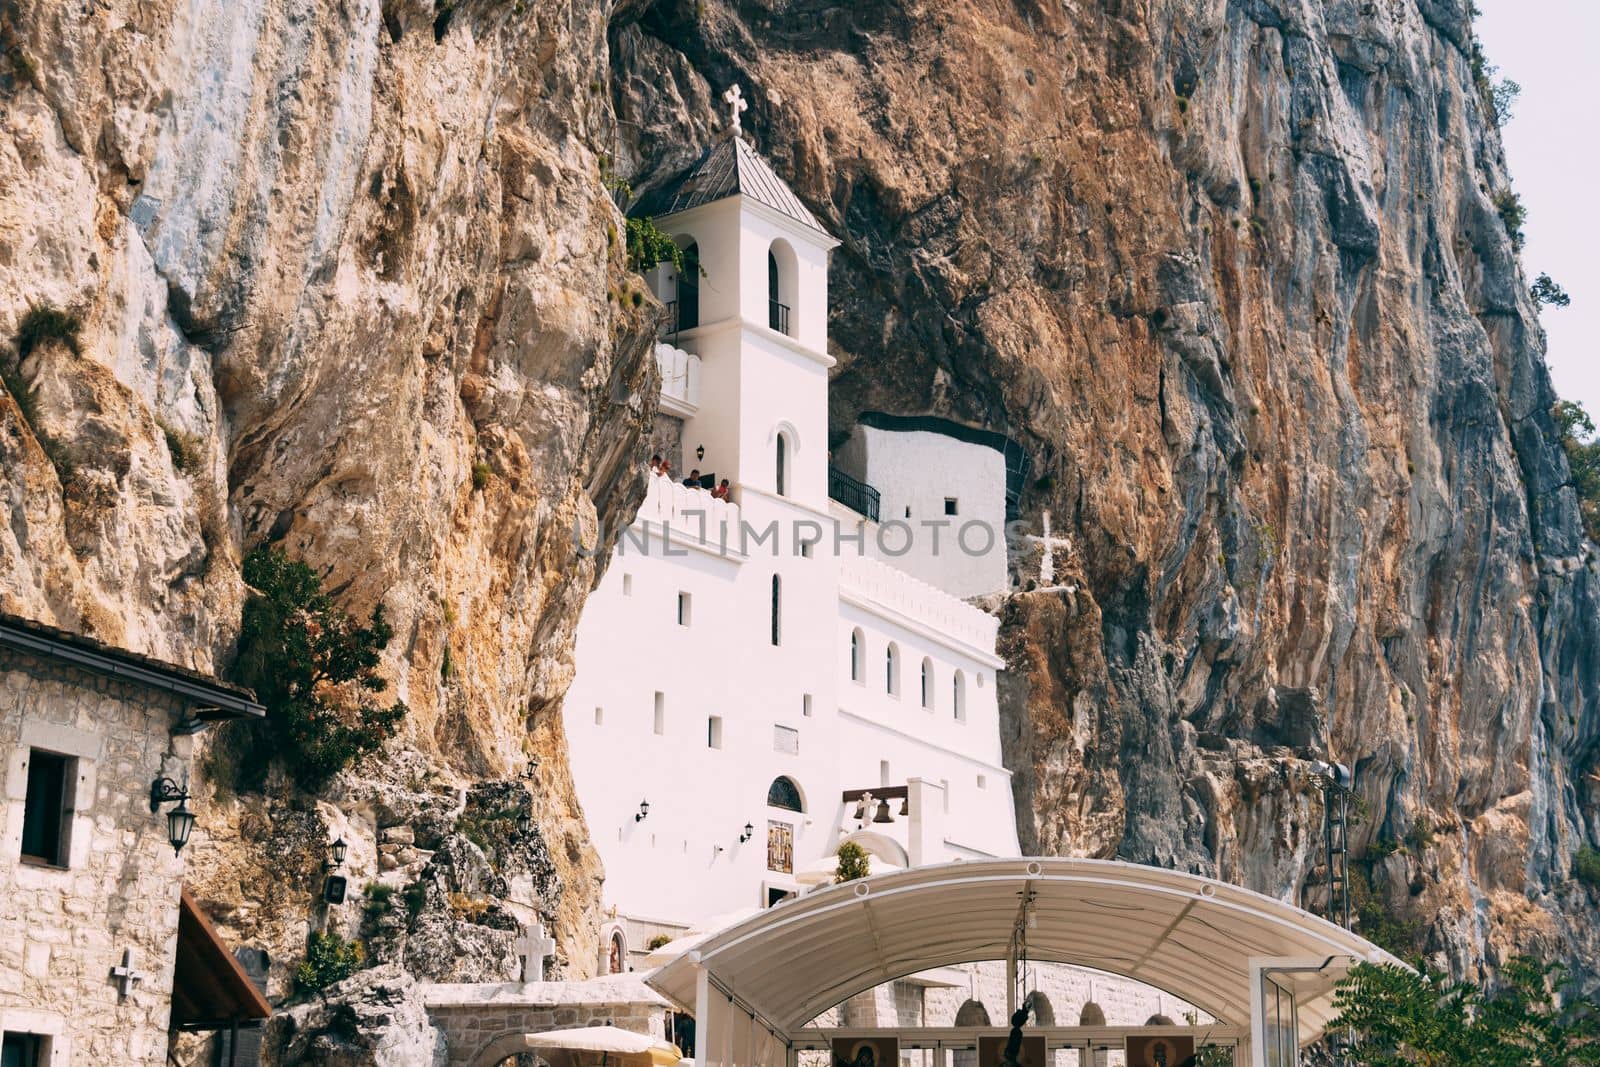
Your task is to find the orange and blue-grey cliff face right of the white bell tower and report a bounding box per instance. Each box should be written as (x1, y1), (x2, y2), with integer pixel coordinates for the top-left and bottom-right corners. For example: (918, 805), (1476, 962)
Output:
(613, 0), (1600, 971)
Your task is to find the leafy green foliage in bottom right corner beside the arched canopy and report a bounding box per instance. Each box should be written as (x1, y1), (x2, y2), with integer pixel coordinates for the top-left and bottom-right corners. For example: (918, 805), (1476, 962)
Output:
(1328, 957), (1600, 1067)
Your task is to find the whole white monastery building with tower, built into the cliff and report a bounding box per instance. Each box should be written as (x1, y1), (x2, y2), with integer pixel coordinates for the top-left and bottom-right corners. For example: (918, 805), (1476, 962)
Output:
(565, 138), (1018, 940)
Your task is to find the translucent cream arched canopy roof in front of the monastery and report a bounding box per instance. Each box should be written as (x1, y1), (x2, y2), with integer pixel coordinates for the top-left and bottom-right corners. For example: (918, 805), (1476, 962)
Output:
(646, 857), (1392, 1040)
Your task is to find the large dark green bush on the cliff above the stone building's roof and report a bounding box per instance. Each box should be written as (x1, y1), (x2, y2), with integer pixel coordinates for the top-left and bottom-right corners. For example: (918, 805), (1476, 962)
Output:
(234, 547), (406, 792)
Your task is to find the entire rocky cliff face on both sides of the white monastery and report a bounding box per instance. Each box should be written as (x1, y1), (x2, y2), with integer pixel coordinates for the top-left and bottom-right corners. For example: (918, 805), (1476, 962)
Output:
(0, 0), (1600, 1017)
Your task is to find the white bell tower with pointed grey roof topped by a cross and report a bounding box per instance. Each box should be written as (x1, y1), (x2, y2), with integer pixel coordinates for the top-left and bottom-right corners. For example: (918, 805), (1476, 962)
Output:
(638, 86), (838, 510)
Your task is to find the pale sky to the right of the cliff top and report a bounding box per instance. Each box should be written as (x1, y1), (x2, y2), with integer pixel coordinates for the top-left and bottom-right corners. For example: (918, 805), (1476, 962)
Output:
(1477, 0), (1600, 422)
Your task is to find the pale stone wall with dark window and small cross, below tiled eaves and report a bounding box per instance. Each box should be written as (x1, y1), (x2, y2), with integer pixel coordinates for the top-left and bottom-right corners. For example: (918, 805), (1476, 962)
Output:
(0, 649), (192, 1067)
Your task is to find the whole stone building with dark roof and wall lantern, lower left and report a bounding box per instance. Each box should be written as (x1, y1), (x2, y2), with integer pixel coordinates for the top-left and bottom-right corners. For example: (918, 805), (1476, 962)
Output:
(0, 614), (266, 1067)
